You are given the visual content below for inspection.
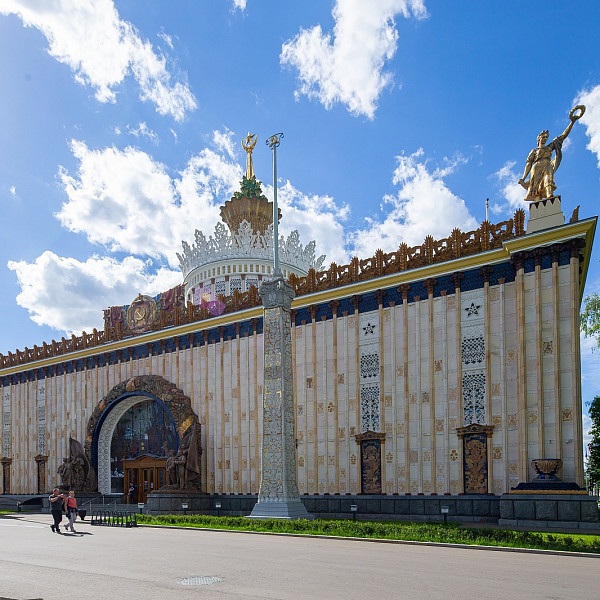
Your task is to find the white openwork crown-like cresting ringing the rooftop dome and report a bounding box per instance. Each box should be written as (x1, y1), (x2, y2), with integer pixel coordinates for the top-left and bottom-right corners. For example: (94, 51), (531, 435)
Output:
(177, 219), (325, 278)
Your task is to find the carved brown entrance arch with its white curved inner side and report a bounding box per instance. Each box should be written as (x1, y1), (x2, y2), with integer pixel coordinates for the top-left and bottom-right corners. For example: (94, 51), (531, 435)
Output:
(85, 375), (198, 494)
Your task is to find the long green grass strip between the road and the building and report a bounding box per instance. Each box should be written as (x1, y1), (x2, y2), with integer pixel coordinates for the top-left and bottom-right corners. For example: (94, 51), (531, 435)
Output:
(137, 515), (600, 554)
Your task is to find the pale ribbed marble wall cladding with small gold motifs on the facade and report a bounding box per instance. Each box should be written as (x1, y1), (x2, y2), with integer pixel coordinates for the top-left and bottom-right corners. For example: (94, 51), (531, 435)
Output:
(0, 253), (580, 494)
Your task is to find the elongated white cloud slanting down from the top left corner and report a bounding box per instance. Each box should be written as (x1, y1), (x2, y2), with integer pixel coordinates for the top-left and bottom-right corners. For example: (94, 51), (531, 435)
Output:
(0, 0), (196, 121)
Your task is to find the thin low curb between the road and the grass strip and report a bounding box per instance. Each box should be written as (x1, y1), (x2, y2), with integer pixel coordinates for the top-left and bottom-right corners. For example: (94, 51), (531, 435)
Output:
(138, 523), (600, 558)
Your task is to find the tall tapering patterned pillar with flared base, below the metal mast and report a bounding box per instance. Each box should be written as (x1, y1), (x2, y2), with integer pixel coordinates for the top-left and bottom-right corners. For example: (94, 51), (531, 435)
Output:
(249, 276), (313, 519)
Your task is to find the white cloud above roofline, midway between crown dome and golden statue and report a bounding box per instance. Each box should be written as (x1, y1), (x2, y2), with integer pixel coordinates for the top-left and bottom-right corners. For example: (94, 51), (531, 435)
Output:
(349, 149), (478, 256)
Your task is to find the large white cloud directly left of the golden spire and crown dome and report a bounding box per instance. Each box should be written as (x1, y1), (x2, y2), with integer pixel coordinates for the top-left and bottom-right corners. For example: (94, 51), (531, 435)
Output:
(57, 141), (241, 267)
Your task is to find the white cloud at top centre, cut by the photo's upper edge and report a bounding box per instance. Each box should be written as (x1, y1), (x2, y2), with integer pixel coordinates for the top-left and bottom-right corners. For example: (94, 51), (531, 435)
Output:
(280, 0), (427, 119)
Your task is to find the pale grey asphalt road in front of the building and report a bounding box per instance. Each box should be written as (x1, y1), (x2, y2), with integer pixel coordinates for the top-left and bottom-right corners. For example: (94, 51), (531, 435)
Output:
(0, 515), (600, 600)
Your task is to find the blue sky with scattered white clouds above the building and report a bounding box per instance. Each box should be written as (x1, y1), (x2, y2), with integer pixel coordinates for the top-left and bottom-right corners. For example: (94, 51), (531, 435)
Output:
(0, 0), (600, 440)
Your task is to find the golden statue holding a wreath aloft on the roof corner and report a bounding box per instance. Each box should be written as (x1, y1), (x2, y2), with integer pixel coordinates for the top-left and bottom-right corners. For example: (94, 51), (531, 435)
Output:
(519, 104), (585, 202)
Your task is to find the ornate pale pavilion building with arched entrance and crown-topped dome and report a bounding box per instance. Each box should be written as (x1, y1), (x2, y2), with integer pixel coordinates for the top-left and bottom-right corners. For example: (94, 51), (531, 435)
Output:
(0, 149), (596, 516)
